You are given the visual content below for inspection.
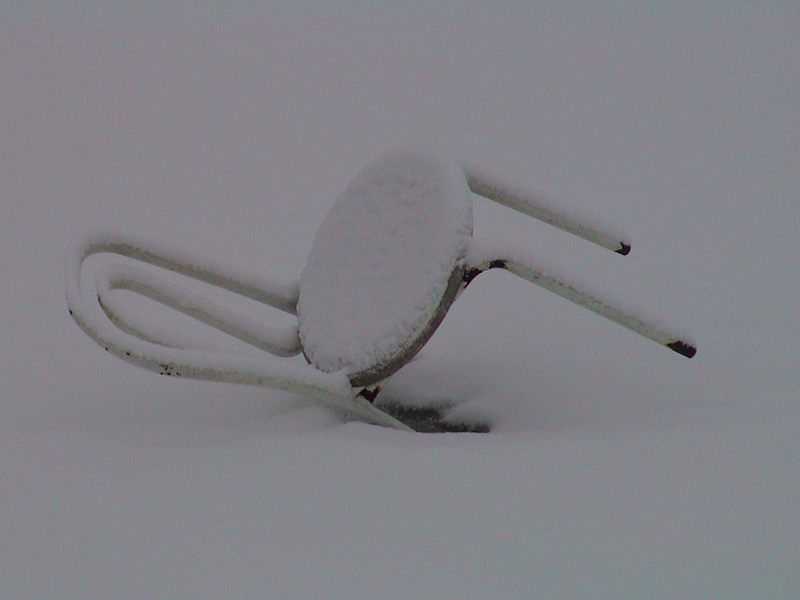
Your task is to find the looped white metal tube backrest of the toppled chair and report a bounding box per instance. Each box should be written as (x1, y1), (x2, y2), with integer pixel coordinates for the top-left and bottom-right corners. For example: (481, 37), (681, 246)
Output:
(66, 234), (409, 430)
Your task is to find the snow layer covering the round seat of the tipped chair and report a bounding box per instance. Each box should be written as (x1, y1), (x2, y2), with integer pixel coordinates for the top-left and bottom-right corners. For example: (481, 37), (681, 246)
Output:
(297, 147), (472, 374)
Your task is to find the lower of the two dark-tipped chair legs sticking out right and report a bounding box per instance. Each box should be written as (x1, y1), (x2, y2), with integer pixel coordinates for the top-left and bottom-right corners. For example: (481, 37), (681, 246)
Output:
(465, 240), (697, 358)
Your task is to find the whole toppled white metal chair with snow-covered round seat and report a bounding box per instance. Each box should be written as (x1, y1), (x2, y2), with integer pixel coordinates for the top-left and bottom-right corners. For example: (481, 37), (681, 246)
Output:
(66, 147), (695, 429)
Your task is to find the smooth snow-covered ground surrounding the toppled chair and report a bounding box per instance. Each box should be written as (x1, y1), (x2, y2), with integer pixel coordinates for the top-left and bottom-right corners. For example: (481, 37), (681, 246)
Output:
(0, 2), (800, 598)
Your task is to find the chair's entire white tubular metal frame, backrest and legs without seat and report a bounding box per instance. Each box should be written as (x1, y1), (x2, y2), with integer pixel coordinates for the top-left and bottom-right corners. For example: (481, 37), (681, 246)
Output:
(65, 159), (696, 430)
